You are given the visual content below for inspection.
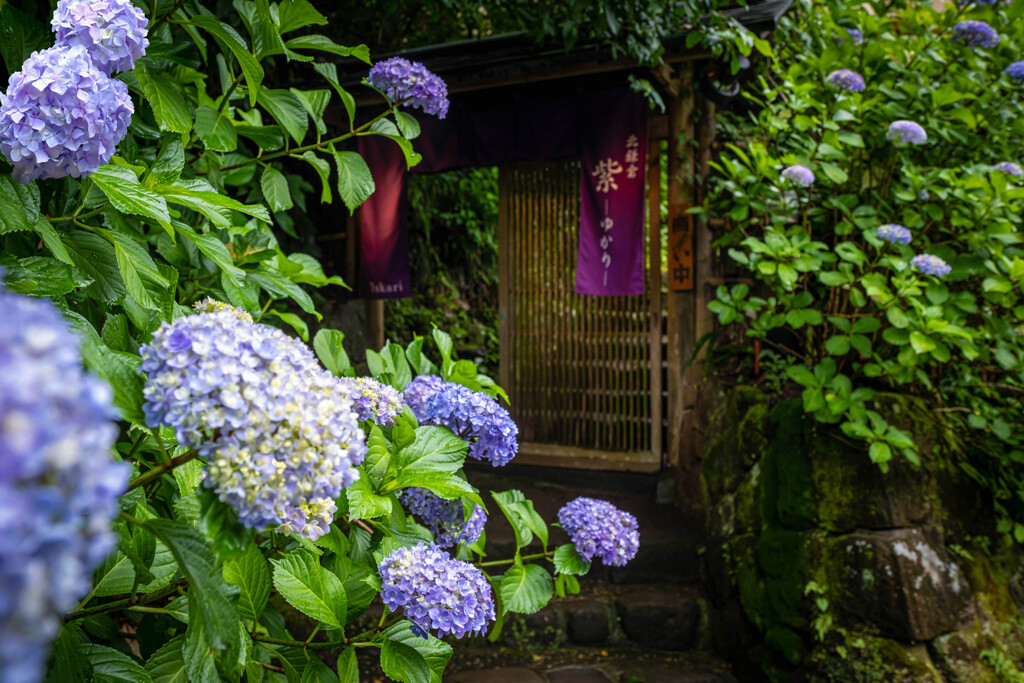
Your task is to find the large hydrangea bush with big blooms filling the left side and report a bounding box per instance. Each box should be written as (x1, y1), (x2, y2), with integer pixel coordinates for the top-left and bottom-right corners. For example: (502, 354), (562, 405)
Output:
(0, 0), (636, 683)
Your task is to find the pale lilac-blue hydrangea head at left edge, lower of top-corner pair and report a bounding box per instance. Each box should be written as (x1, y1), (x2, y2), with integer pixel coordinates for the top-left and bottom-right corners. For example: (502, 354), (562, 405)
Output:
(0, 46), (135, 184)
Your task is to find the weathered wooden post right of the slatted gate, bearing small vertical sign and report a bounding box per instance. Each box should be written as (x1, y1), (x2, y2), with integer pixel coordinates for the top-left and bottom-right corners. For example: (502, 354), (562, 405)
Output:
(666, 70), (700, 508)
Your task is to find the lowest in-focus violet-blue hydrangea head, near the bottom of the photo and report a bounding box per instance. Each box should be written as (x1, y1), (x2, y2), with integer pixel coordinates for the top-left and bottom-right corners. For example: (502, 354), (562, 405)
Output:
(378, 543), (495, 638)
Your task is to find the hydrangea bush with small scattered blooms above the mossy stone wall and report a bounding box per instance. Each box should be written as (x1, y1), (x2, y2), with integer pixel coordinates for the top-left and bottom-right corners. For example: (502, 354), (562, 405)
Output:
(700, 0), (1024, 542)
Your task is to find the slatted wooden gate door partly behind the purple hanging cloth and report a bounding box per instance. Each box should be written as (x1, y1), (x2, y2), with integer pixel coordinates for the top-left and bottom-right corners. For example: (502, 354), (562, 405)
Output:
(499, 158), (662, 471)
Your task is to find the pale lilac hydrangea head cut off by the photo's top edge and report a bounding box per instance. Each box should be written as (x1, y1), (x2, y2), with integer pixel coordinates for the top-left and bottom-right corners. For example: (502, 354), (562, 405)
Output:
(50, 0), (150, 76)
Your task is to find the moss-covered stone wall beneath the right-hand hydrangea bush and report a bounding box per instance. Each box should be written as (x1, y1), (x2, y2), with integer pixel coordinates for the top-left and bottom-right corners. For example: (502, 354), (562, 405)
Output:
(702, 387), (1024, 683)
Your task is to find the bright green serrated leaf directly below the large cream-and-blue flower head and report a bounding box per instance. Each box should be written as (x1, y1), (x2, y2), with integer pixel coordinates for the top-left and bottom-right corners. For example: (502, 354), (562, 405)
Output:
(271, 550), (348, 629)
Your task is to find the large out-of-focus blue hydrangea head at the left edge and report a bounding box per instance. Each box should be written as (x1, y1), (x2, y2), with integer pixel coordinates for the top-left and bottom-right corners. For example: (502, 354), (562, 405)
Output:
(0, 290), (131, 683)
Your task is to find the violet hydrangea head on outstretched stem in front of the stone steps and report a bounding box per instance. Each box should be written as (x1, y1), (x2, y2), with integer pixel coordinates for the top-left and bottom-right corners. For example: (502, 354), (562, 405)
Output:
(558, 498), (640, 567)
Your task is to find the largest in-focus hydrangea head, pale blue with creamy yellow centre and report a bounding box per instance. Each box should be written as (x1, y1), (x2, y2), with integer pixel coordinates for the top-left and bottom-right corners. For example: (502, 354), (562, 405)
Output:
(139, 302), (367, 540)
